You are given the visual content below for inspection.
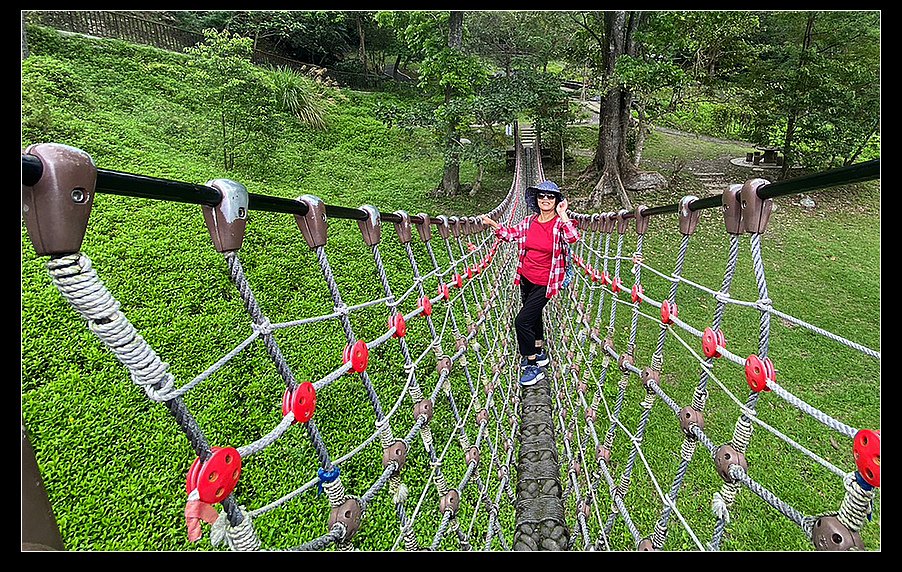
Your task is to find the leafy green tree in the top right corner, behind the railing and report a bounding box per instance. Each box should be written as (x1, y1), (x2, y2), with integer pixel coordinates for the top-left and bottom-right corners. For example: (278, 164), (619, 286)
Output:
(744, 11), (880, 172)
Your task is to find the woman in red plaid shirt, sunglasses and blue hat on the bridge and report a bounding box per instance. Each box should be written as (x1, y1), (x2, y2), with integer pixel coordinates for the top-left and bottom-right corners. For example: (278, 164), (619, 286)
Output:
(482, 181), (579, 386)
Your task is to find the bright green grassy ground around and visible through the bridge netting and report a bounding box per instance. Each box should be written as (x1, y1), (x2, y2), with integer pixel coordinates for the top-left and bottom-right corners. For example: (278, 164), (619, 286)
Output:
(22, 25), (880, 550)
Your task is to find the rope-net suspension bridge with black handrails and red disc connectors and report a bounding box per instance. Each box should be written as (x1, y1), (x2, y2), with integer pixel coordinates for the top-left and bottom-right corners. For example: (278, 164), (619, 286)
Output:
(22, 127), (880, 551)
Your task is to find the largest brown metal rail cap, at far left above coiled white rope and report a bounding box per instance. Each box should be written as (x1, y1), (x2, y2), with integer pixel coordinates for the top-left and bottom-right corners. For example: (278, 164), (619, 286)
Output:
(22, 143), (97, 256)
